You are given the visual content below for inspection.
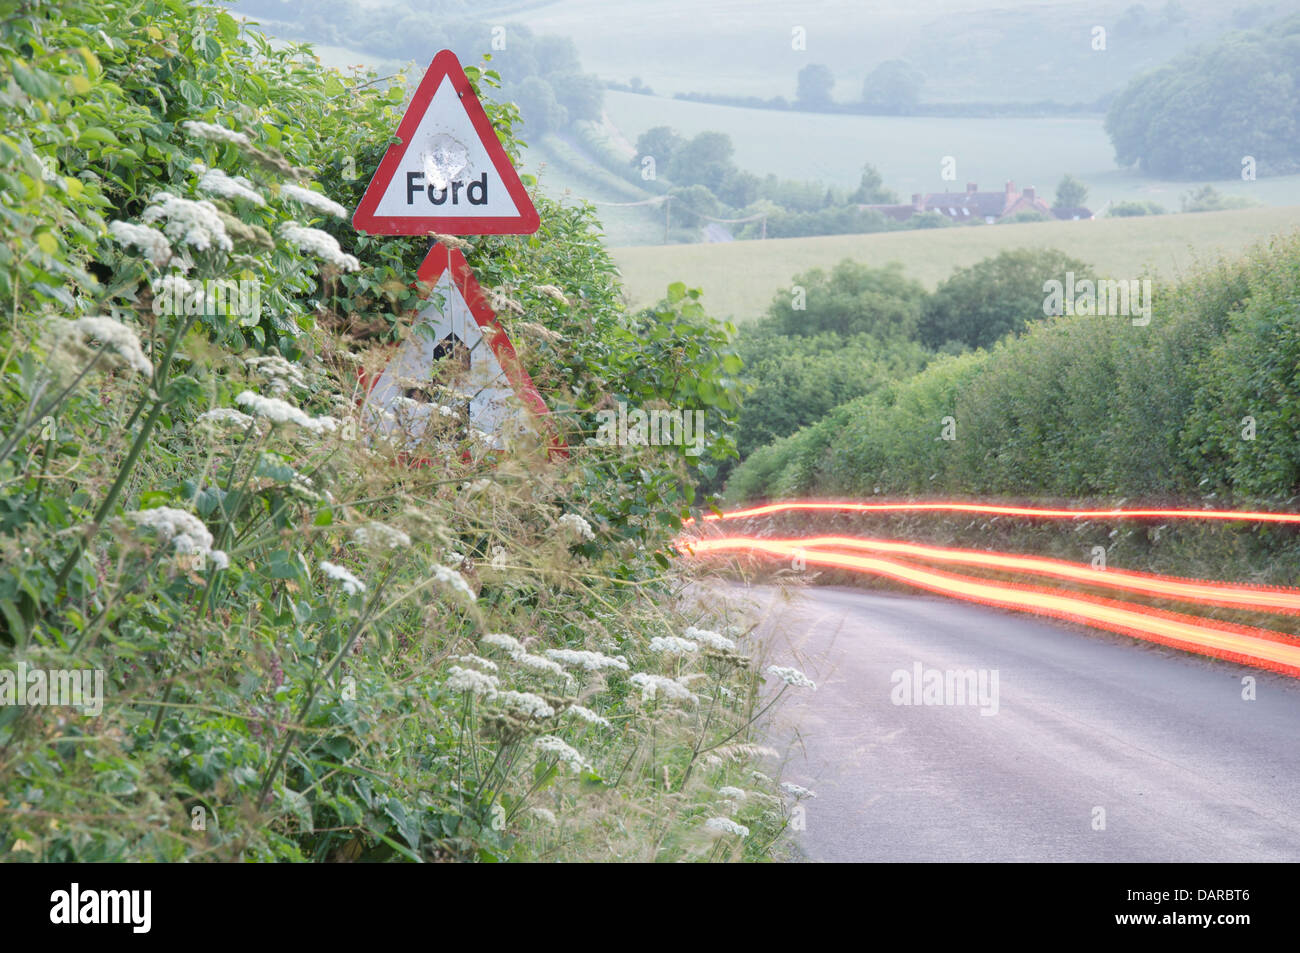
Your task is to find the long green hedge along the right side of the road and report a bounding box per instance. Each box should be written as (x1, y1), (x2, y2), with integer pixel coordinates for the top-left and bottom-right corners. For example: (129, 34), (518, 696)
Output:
(728, 235), (1300, 545)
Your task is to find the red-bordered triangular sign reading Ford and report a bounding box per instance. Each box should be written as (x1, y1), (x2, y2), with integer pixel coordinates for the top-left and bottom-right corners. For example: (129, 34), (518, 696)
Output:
(352, 49), (540, 235)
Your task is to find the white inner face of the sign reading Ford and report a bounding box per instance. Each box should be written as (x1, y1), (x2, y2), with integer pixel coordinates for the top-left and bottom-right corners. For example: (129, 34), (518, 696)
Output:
(374, 77), (520, 218)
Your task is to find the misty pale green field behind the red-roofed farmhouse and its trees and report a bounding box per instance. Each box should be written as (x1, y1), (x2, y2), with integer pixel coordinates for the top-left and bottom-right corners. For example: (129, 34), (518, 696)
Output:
(605, 92), (1300, 211)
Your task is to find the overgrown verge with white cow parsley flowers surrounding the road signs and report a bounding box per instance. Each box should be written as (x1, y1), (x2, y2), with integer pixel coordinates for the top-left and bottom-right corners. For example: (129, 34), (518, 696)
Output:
(0, 0), (821, 861)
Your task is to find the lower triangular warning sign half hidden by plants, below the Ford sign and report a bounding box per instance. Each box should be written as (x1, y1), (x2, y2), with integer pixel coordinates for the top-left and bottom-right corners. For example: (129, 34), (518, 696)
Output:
(368, 243), (567, 456)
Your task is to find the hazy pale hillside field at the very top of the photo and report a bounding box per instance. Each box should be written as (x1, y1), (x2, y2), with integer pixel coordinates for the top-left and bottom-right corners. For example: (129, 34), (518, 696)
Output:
(512, 0), (1234, 103)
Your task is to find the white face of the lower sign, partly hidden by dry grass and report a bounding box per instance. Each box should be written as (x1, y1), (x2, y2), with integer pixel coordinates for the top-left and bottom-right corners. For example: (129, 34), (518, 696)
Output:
(369, 270), (529, 447)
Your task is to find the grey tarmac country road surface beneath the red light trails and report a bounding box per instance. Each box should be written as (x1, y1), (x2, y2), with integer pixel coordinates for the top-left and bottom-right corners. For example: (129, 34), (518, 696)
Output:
(720, 586), (1300, 863)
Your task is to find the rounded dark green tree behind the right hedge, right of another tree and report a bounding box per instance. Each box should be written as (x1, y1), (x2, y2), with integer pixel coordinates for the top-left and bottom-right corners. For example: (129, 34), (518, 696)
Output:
(918, 248), (1089, 350)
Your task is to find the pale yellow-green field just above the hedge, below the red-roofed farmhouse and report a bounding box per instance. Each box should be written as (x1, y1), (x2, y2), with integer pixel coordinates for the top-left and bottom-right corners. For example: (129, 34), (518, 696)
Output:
(612, 205), (1300, 321)
